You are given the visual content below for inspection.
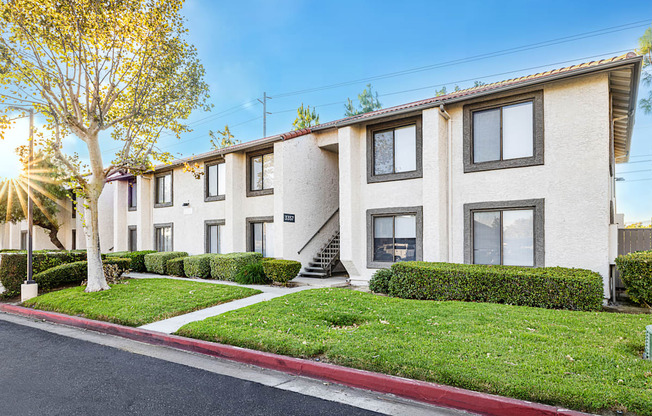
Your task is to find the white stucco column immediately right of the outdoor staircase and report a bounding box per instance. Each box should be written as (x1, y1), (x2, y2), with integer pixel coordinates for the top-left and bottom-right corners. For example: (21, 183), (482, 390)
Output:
(338, 126), (366, 281)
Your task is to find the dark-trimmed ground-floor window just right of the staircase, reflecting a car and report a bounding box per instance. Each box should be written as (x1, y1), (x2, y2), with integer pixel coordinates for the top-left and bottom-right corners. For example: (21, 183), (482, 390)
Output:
(367, 206), (423, 268)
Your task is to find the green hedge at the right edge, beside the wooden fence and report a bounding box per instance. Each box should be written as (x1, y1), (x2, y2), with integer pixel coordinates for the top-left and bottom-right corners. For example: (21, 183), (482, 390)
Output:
(616, 251), (652, 306)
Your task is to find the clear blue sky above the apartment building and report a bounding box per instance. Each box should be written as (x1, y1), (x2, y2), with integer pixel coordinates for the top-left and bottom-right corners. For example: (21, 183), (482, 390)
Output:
(0, 0), (652, 222)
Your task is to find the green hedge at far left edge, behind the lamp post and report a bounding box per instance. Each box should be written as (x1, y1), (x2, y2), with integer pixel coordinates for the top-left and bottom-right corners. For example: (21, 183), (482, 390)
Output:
(0, 251), (86, 297)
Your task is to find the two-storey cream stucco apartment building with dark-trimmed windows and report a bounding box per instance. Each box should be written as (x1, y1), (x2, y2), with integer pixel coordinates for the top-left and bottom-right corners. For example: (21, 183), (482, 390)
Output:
(3, 53), (641, 298)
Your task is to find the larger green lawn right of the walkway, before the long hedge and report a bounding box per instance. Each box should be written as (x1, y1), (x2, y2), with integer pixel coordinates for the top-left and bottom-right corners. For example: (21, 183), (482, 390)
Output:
(178, 289), (652, 415)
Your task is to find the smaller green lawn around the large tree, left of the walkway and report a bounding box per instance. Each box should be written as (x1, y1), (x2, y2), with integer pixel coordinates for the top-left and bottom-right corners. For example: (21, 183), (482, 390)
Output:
(24, 279), (261, 326)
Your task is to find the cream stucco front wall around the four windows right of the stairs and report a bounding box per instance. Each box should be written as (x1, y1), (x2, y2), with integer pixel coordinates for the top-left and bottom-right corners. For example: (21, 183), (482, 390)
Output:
(339, 74), (611, 295)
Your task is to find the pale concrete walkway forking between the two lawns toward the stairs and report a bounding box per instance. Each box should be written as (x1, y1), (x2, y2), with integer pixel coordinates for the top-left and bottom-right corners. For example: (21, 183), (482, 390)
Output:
(127, 272), (346, 334)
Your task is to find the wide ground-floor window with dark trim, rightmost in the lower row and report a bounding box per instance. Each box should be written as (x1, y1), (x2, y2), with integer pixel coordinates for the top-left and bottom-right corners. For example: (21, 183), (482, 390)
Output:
(464, 199), (544, 267)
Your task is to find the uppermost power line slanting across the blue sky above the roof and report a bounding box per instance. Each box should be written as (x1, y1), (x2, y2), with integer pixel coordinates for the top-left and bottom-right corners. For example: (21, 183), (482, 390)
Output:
(274, 19), (649, 98)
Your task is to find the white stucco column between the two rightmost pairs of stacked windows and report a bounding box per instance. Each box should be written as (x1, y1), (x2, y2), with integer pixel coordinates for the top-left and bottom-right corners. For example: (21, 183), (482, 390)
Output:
(422, 108), (449, 261)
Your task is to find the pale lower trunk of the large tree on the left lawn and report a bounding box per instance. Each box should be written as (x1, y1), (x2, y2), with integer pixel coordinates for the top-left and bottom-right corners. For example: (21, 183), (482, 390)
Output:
(84, 189), (110, 292)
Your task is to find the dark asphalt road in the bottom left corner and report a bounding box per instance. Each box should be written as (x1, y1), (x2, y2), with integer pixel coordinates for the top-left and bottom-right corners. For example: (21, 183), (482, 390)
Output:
(0, 320), (377, 416)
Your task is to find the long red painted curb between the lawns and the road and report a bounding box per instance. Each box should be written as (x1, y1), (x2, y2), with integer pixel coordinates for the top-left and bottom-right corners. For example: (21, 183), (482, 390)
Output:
(0, 304), (587, 416)
